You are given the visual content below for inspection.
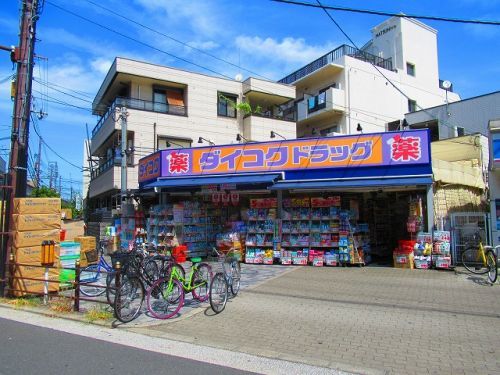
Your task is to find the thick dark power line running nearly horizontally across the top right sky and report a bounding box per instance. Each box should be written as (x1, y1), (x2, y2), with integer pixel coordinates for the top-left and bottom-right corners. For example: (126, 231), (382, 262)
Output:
(271, 0), (500, 26)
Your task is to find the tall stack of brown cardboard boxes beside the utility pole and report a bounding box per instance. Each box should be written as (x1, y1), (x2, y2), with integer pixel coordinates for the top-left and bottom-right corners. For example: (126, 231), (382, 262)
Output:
(12, 198), (61, 296)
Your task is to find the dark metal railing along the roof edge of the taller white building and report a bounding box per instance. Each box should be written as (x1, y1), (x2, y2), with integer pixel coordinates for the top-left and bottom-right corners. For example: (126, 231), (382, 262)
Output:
(278, 44), (392, 84)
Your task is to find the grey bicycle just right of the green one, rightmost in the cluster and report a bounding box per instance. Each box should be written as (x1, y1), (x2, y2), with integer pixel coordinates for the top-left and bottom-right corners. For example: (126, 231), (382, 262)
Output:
(209, 248), (241, 314)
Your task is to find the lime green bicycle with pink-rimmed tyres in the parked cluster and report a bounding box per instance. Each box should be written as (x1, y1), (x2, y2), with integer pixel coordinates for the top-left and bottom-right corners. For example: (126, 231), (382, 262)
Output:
(146, 258), (212, 319)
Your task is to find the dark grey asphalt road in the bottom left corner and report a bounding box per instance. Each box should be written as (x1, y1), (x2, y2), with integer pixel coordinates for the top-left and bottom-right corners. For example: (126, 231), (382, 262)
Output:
(0, 318), (251, 375)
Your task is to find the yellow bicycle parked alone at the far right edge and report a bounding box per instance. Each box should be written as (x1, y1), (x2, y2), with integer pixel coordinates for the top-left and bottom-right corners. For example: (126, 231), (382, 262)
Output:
(462, 233), (500, 284)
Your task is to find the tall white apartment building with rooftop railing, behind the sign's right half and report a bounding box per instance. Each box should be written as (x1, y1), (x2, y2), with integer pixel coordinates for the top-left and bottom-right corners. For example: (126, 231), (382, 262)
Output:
(279, 17), (459, 137)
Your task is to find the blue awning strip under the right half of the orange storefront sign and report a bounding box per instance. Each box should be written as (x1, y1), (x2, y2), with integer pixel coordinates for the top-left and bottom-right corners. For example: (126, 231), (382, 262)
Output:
(270, 176), (432, 190)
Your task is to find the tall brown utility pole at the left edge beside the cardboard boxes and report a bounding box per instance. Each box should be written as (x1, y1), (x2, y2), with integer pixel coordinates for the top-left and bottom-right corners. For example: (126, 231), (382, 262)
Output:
(0, 0), (41, 296)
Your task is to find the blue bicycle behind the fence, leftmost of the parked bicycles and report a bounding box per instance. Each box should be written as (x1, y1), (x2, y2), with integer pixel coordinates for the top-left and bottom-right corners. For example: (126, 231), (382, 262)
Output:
(80, 241), (114, 297)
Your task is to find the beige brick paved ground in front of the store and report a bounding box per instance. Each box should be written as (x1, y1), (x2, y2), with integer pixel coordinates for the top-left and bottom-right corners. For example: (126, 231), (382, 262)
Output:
(131, 266), (500, 374)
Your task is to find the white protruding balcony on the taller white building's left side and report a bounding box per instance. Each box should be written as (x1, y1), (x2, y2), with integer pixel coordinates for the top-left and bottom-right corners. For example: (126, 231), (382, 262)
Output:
(297, 87), (345, 122)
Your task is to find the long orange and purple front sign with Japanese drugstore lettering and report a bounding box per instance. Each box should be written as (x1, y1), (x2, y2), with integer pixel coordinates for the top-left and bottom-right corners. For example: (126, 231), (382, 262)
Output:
(153, 130), (430, 178)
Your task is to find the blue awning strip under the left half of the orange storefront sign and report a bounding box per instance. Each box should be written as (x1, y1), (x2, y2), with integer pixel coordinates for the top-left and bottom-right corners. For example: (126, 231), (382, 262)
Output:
(144, 173), (282, 189)
